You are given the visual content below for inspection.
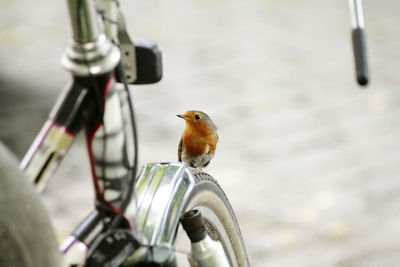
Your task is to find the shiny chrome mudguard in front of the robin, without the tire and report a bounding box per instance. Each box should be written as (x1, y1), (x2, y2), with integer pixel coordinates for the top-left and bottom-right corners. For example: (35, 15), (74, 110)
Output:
(136, 162), (195, 245)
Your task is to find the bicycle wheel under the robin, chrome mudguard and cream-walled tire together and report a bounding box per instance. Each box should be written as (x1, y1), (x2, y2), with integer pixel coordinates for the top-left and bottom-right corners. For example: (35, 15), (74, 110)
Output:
(134, 162), (249, 267)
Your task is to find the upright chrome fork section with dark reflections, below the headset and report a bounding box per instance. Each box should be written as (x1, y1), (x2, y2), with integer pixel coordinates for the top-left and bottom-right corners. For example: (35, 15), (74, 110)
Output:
(88, 79), (134, 209)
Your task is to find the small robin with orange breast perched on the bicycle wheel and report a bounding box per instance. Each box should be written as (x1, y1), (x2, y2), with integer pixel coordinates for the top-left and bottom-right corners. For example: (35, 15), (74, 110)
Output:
(177, 110), (218, 168)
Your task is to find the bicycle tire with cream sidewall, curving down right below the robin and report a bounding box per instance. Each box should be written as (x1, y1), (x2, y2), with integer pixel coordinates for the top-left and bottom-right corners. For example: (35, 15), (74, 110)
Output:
(177, 168), (250, 267)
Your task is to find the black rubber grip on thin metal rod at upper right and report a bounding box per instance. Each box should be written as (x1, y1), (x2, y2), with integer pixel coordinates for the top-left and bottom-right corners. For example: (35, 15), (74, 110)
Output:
(352, 28), (369, 86)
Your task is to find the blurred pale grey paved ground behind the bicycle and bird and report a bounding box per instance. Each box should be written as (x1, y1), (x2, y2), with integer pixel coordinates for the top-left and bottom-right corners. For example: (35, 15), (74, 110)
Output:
(0, 0), (400, 266)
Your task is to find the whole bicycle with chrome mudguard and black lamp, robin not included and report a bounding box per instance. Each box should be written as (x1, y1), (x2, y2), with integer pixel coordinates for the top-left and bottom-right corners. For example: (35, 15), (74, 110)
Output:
(0, 0), (249, 266)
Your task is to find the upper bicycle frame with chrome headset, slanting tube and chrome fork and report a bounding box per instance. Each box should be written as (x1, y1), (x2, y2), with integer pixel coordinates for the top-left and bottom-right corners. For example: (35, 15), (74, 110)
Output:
(21, 0), (123, 209)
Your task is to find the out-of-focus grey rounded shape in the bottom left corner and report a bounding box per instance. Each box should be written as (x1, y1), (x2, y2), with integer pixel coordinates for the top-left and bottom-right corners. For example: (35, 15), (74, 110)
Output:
(0, 142), (61, 267)
